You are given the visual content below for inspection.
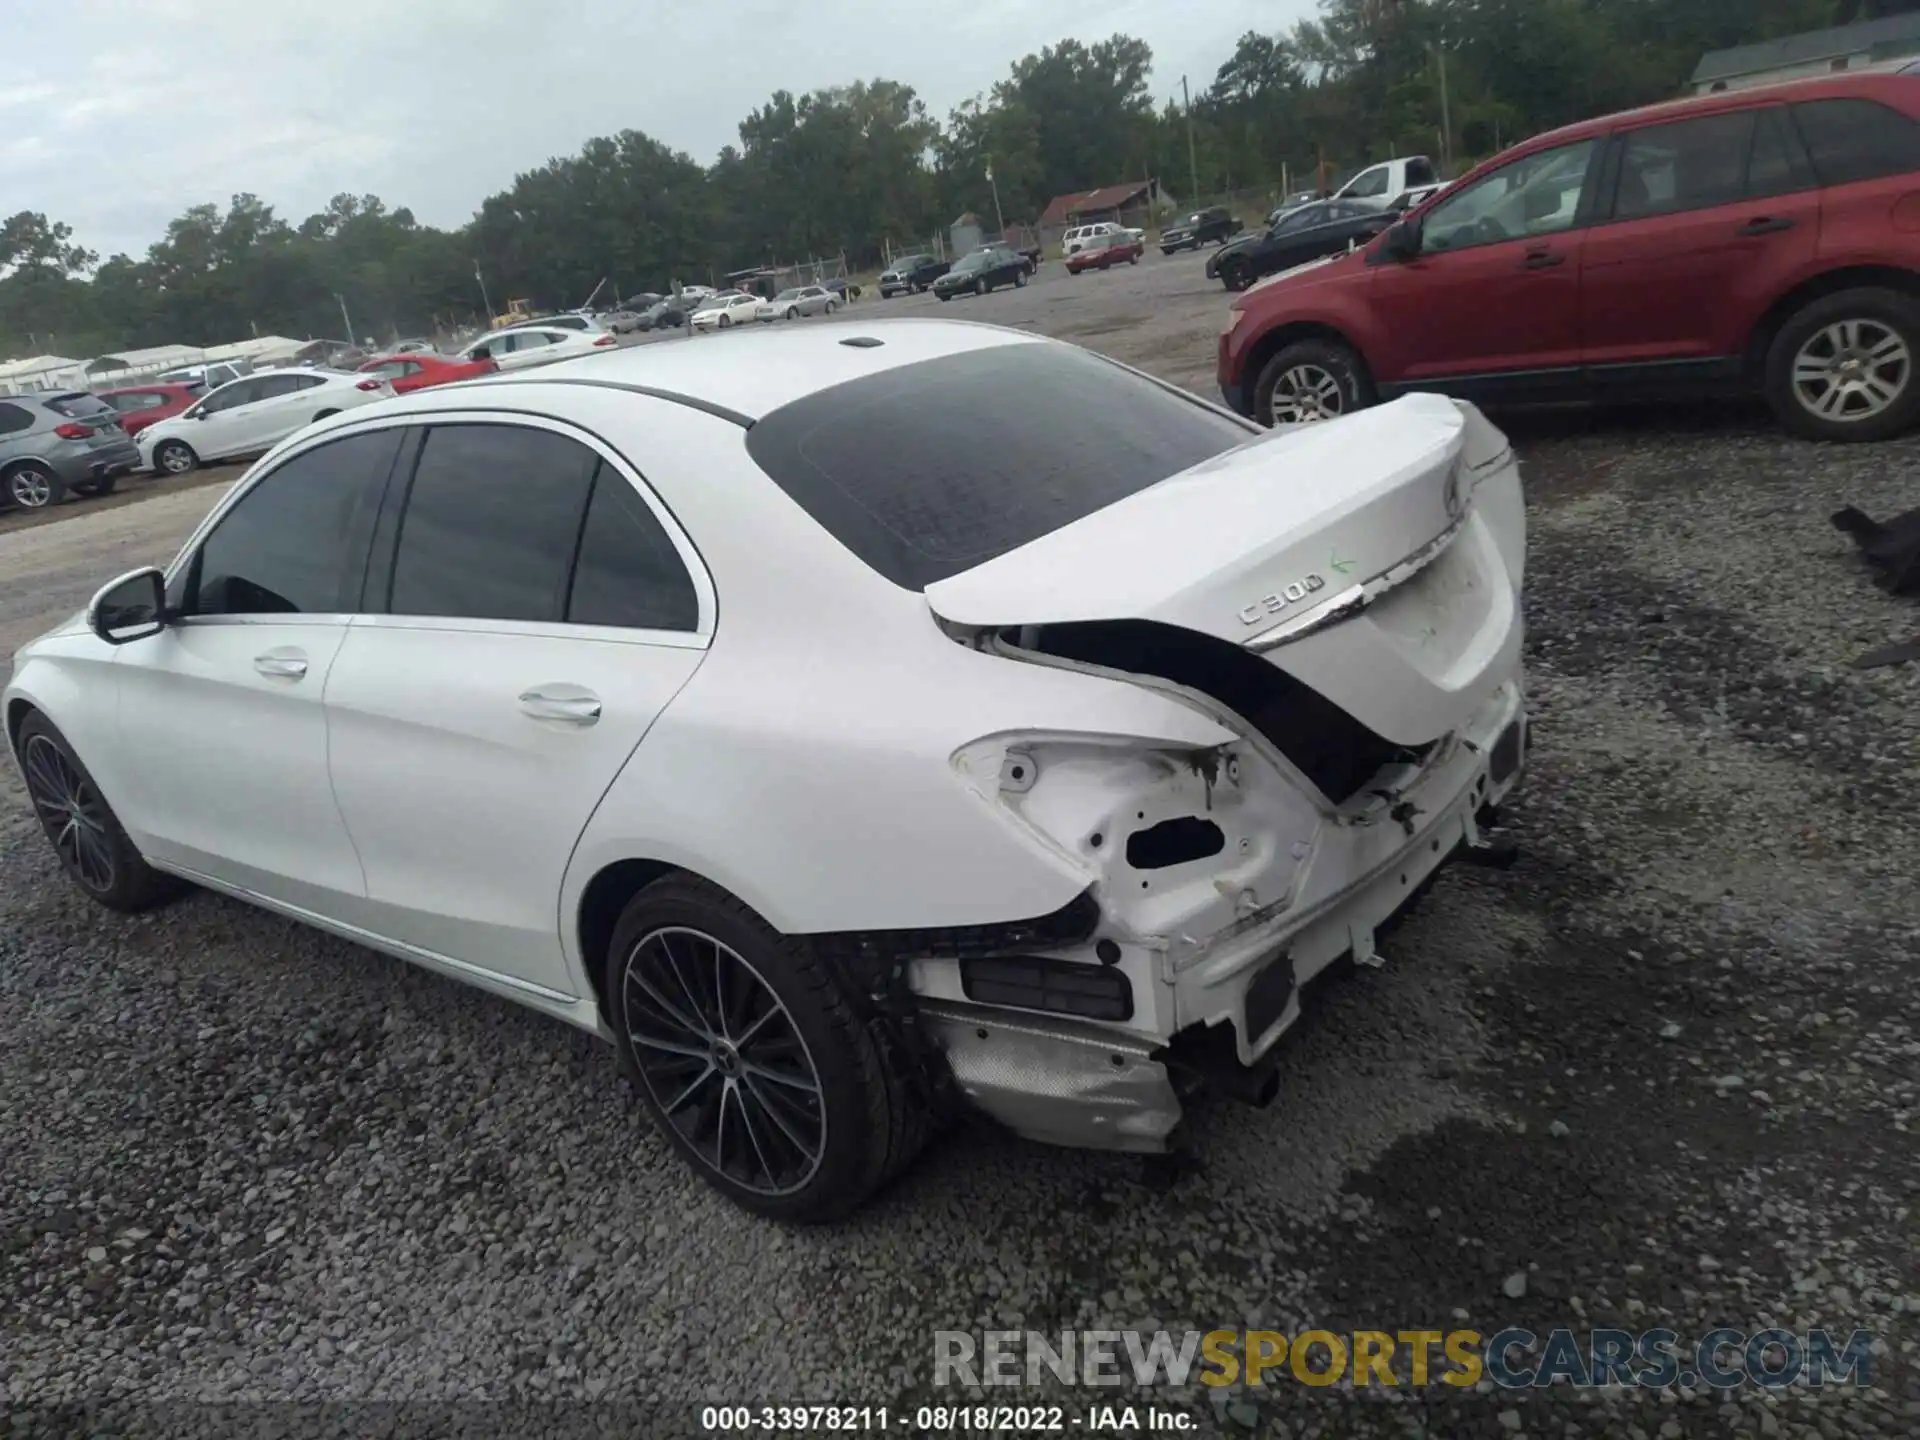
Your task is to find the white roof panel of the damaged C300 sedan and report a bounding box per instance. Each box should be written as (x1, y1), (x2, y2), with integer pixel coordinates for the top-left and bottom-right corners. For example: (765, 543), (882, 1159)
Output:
(353, 319), (1054, 422)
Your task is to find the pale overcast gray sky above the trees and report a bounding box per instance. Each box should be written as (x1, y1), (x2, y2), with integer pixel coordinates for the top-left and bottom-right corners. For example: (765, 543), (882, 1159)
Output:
(0, 0), (1315, 257)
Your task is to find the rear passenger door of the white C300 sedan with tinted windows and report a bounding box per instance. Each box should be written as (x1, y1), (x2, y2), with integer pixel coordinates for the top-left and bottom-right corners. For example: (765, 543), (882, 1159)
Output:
(326, 416), (714, 996)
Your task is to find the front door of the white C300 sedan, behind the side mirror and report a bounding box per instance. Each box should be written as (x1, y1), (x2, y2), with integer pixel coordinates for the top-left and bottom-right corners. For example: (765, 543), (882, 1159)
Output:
(113, 426), (403, 918)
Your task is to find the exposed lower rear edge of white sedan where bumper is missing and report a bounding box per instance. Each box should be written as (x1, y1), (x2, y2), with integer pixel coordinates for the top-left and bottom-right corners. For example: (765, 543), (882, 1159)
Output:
(920, 682), (1526, 1154)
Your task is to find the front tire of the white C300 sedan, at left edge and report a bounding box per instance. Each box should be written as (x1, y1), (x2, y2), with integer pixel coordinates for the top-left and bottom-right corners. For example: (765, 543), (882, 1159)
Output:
(17, 710), (188, 912)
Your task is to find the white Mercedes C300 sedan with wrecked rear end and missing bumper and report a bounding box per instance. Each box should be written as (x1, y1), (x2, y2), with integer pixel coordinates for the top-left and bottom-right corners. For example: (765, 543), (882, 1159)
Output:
(4, 321), (1526, 1219)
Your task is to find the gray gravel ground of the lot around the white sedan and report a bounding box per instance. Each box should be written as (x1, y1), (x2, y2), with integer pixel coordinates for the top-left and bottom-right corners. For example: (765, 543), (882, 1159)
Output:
(0, 257), (1920, 1440)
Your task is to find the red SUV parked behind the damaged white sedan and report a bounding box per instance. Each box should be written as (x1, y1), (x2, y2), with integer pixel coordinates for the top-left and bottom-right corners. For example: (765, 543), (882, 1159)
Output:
(1219, 73), (1920, 440)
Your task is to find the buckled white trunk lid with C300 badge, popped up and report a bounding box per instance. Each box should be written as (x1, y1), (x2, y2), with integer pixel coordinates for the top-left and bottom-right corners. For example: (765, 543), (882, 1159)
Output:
(925, 396), (1524, 747)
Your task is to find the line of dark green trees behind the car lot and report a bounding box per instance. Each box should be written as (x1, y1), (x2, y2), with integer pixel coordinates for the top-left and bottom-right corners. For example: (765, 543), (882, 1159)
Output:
(0, 0), (1920, 357)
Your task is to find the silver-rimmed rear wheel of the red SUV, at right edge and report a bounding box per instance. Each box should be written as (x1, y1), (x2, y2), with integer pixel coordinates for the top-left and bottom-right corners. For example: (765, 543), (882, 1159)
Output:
(1766, 288), (1920, 440)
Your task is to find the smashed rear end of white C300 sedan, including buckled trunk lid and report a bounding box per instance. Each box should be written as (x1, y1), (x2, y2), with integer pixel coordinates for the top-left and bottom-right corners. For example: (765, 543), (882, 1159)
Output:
(914, 396), (1526, 1150)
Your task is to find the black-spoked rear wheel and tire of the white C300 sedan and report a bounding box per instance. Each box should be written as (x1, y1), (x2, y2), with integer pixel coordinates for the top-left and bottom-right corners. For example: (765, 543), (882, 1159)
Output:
(605, 876), (929, 1221)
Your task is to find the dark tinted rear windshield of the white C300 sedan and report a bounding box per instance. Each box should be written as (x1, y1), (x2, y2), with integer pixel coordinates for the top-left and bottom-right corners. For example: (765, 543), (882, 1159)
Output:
(747, 344), (1254, 589)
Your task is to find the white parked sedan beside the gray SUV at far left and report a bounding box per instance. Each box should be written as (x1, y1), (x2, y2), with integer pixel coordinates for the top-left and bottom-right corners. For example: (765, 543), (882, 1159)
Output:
(136, 371), (394, 474)
